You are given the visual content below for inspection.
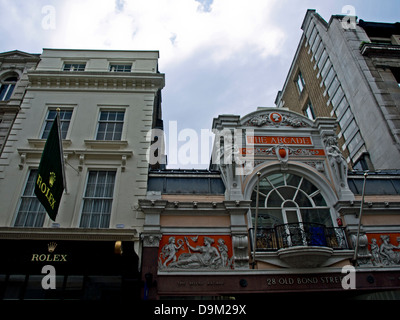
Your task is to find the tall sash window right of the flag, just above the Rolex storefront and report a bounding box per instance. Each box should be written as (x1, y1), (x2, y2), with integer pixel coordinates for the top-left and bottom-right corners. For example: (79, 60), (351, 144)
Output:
(80, 171), (115, 228)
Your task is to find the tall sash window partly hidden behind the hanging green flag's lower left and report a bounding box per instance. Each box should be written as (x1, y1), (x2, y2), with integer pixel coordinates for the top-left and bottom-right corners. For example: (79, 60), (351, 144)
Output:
(14, 170), (46, 228)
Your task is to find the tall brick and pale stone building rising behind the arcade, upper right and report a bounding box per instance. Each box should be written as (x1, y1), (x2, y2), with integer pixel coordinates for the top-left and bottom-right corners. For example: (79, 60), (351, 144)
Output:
(276, 10), (400, 170)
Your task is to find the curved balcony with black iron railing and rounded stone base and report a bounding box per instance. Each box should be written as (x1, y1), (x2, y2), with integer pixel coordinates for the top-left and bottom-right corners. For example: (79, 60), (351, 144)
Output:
(250, 222), (349, 268)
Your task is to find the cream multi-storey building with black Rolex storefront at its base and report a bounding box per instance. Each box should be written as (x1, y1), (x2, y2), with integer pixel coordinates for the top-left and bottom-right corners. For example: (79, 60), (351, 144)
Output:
(0, 49), (165, 299)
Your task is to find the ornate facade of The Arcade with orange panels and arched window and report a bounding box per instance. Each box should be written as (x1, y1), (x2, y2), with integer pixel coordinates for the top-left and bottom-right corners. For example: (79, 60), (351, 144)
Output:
(139, 108), (400, 299)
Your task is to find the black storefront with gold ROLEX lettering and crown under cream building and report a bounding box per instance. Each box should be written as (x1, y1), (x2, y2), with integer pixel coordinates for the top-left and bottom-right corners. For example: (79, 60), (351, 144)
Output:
(0, 230), (140, 301)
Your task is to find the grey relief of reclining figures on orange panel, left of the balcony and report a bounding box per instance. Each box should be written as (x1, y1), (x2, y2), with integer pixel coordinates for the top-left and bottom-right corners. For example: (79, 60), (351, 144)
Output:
(158, 236), (233, 270)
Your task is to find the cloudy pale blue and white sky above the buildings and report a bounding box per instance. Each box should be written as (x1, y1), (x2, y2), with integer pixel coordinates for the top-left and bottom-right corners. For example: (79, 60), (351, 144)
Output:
(0, 0), (400, 169)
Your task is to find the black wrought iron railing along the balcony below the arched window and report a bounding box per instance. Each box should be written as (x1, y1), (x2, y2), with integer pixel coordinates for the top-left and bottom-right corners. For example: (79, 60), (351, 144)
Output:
(249, 222), (349, 251)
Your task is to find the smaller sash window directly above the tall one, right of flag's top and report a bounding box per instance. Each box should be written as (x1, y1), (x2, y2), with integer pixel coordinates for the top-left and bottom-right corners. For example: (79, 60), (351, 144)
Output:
(96, 111), (125, 141)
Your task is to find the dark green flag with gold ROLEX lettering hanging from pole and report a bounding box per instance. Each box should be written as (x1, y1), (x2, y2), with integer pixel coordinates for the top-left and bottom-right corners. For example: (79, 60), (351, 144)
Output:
(35, 112), (65, 221)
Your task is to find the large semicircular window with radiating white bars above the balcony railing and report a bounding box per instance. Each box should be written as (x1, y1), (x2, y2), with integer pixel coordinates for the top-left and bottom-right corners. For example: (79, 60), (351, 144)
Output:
(251, 173), (333, 228)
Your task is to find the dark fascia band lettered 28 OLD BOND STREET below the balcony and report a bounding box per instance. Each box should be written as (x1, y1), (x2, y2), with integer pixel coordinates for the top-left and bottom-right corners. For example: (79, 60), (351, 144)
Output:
(158, 269), (400, 300)
